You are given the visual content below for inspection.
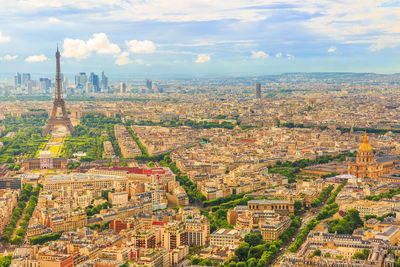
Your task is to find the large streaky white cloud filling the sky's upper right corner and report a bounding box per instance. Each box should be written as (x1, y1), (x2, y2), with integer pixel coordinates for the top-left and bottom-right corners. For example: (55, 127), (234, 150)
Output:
(297, 0), (400, 51)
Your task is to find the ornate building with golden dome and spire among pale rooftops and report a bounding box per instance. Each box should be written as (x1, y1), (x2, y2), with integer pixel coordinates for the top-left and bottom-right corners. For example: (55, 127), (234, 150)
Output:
(348, 133), (394, 179)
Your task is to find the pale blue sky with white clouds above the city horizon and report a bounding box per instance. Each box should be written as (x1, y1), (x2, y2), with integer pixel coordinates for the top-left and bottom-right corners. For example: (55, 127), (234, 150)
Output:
(0, 0), (400, 77)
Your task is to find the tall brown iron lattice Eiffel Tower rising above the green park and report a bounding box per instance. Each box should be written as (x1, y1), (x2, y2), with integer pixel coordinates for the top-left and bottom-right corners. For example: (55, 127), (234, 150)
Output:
(43, 45), (74, 135)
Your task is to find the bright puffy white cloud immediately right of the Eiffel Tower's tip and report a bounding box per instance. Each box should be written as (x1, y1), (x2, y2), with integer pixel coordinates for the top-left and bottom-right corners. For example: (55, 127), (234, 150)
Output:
(63, 33), (121, 59)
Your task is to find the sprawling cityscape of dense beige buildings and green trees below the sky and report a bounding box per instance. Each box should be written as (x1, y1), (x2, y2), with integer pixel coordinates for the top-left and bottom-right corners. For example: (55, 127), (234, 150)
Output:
(0, 60), (400, 267)
